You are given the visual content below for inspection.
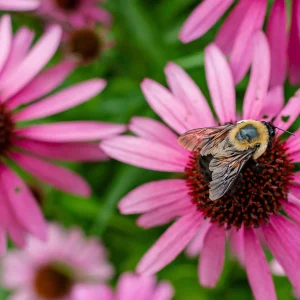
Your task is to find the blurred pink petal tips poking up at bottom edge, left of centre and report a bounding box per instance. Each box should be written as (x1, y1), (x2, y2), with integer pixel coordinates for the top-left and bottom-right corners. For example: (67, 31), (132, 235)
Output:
(73, 273), (174, 300)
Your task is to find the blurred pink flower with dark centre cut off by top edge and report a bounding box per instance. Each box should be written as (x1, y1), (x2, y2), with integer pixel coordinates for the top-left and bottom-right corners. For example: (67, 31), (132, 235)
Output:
(37, 0), (112, 28)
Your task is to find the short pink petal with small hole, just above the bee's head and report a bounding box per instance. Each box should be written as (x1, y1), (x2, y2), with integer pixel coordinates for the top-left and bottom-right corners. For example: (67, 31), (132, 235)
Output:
(261, 85), (284, 120)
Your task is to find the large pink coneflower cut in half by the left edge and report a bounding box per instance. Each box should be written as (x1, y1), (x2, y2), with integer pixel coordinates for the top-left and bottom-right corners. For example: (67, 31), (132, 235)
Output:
(0, 16), (125, 253)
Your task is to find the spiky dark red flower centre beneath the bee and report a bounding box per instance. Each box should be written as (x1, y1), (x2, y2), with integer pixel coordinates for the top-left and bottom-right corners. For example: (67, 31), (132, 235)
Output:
(186, 139), (294, 229)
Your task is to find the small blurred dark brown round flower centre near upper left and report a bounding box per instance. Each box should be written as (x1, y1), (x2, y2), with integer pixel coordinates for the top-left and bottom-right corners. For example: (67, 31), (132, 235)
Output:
(69, 28), (103, 62)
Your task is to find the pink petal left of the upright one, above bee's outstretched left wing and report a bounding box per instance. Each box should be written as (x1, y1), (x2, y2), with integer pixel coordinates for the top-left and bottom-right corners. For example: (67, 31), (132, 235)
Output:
(165, 62), (216, 128)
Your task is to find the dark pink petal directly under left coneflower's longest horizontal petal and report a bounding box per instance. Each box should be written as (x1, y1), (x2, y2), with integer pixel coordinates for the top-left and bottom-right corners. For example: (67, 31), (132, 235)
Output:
(14, 139), (108, 162)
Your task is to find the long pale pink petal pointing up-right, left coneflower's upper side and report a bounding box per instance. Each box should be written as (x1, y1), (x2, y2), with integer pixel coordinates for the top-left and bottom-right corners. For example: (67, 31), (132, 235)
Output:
(0, 25), (62, 100)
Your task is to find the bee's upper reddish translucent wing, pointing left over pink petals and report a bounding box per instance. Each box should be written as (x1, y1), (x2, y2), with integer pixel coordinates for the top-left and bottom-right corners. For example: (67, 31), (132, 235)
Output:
(178, 123), (234, 155)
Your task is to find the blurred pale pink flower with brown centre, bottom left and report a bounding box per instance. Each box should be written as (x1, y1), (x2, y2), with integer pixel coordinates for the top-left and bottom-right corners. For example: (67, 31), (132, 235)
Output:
(1, 224), (113, 300)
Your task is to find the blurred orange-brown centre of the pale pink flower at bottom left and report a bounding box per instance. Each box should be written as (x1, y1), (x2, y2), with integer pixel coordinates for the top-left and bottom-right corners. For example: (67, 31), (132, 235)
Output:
(34, 265), (73, 299)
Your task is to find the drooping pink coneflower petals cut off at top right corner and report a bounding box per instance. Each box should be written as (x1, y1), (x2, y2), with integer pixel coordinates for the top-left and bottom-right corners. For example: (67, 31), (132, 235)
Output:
(179, 0), (300, 87)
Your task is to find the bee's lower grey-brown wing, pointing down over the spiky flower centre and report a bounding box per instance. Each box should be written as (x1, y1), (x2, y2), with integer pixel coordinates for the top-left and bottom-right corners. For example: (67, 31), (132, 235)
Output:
(209, 147), (255, 200)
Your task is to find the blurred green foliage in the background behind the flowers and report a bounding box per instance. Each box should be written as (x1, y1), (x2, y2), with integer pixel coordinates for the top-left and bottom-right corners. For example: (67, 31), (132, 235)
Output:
(0, 0), (300, 300)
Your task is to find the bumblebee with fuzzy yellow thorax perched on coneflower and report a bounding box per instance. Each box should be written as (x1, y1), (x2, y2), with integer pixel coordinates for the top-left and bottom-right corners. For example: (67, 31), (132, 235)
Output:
(178, 120), (277, 200)
